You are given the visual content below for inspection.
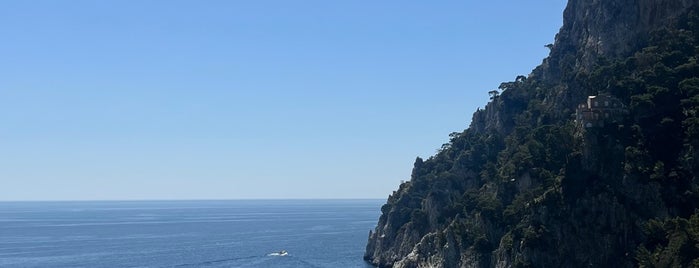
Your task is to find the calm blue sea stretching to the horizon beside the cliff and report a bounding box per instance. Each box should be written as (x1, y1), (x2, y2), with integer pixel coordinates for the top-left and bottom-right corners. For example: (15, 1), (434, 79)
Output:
(0, 200), (385, 268)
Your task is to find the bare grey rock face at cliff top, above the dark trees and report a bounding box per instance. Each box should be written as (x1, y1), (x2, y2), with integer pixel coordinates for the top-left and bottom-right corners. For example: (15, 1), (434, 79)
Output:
(532, 0), (697, 119)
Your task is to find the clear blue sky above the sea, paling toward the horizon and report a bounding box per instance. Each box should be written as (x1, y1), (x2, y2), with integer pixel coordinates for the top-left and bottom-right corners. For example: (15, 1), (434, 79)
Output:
(0, 0), (565, 200)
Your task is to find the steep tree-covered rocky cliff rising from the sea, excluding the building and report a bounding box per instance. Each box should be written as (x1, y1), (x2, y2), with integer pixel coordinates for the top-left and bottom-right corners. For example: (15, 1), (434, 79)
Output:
(365, 0), (699, 267)
